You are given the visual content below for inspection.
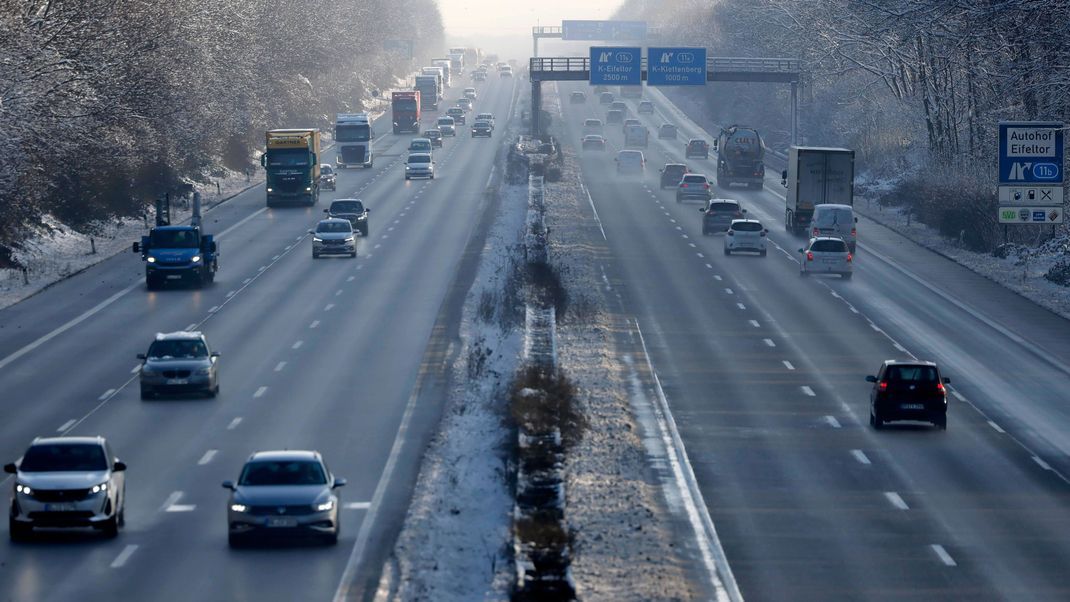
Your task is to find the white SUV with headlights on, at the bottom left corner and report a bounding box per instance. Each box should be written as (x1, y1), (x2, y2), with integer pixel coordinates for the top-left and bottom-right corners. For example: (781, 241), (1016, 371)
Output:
(3, 436), (126, 541)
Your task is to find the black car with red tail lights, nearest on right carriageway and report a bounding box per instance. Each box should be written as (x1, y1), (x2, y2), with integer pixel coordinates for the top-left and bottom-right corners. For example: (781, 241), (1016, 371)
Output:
(866, 359), (951, 430)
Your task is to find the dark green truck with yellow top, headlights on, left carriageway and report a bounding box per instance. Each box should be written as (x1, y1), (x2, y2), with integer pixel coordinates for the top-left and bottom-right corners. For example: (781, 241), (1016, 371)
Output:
(260, 127), (320, 206)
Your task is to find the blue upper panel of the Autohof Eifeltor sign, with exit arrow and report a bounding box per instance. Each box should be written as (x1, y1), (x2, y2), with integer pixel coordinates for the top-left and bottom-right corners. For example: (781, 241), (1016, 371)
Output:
(999, 121), (1064, 185)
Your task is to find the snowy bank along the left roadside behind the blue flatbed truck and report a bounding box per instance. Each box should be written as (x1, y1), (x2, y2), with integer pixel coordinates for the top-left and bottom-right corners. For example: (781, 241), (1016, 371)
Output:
(0, 171), (263, 309)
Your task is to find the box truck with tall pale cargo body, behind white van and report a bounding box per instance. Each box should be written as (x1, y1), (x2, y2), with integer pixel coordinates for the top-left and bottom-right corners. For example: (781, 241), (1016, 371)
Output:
(781, 146), (855, 234)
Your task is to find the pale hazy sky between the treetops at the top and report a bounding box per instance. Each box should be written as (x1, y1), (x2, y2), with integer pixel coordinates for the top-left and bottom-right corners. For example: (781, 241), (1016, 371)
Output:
(439, 0), (622, 35)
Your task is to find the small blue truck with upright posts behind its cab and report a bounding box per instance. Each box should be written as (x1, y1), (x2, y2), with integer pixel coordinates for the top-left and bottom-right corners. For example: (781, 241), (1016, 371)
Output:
(134, 192), (219, 291)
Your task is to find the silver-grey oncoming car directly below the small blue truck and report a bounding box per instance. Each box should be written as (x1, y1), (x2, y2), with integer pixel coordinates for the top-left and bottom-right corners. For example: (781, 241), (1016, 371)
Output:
(137, 331), (219, 399)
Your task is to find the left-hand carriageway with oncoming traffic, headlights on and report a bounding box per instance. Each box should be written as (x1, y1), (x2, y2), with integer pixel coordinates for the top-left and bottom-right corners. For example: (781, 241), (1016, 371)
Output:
(0, 69), (519, 601)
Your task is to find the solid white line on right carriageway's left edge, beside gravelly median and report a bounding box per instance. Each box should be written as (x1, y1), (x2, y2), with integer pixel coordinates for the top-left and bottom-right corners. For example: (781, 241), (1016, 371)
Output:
(635, 320), (743, 602)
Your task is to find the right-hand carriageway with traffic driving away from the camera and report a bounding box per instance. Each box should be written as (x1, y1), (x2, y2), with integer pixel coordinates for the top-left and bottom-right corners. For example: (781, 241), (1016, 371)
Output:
(556, 82), (1070, 601)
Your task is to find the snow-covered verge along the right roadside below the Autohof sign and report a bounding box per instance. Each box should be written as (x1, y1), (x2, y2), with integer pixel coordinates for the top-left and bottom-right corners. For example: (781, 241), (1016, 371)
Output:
(855, 198), (1070, 320)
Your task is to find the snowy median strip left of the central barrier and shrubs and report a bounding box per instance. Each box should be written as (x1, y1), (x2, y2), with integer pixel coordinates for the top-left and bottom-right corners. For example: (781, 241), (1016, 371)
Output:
(381, 176), (528, 602)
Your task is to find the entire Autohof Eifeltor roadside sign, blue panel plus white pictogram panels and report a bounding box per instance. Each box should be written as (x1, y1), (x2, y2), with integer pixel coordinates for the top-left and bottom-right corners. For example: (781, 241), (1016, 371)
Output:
(998, 122), (1065, 223)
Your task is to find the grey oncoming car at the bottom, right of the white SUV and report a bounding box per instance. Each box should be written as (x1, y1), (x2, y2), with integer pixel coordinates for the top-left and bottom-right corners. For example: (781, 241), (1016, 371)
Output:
(223, 450), (346, 546)
